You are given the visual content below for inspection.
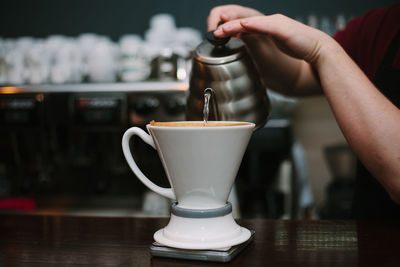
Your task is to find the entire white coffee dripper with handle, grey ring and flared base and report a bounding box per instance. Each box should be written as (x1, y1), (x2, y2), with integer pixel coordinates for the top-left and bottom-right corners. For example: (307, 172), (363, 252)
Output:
(122, 121), (255, 250)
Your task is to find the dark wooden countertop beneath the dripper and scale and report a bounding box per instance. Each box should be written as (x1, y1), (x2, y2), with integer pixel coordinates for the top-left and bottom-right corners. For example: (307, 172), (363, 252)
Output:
(0, 214), (400, 267)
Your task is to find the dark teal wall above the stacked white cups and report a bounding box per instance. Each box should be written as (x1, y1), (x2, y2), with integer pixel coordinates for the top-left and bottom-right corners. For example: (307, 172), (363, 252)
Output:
(0, 0), (398, 39)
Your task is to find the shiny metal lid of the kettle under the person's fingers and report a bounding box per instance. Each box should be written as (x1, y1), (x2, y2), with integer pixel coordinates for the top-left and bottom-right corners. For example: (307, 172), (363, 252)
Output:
(195, 38), (245, 64)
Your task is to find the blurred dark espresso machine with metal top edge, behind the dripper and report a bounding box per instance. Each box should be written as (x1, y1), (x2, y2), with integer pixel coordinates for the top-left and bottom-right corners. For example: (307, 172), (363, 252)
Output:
(0, 81), (187, 215)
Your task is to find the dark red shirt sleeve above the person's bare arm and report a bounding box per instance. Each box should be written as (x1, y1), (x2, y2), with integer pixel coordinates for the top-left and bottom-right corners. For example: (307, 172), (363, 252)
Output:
(334, 4), (400, 81)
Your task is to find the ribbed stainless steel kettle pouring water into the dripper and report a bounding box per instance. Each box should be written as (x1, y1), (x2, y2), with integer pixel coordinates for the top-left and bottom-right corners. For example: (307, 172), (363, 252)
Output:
(186, 38), (270, 128)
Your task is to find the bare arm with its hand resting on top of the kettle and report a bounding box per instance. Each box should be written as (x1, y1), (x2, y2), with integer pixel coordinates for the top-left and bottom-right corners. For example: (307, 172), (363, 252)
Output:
(215, 11), (400, 204)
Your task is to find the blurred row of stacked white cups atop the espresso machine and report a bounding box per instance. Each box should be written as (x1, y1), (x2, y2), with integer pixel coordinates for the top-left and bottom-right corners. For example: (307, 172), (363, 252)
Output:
(0, 14), (202, 84)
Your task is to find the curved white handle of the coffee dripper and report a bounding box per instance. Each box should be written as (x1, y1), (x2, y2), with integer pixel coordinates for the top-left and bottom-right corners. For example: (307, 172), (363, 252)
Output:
(122, 127), (176, 199)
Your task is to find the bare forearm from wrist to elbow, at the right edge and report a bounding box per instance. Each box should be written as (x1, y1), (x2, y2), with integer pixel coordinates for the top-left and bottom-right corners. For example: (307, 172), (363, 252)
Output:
(315, 41), (400, 203)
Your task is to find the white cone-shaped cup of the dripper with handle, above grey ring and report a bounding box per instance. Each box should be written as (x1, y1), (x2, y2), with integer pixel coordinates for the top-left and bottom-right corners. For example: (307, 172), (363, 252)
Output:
(122, 121), (255, 209)
